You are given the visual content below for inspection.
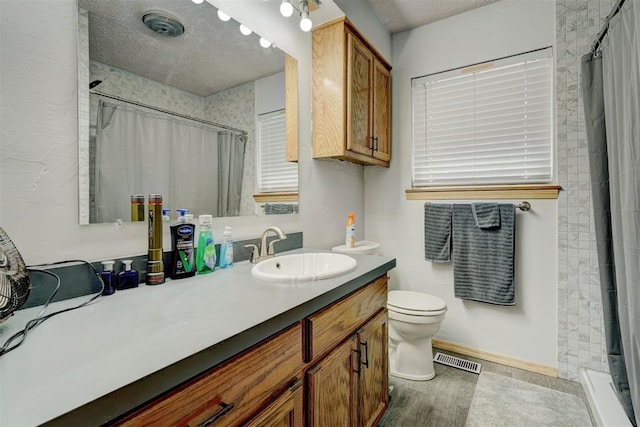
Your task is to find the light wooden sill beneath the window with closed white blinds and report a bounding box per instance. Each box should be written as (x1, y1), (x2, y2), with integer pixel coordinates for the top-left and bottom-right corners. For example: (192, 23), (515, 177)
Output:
(405, 185), (562, 200)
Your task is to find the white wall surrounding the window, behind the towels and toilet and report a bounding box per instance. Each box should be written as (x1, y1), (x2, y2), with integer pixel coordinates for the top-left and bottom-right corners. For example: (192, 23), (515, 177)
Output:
(365, 0), (557, 367)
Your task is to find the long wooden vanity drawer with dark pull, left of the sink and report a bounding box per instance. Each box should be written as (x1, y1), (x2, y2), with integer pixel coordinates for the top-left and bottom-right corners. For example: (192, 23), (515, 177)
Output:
(120, 323), (302, 427)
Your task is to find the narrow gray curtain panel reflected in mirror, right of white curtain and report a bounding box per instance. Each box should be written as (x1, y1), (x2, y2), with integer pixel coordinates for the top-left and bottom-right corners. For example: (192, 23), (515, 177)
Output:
(217, 132), (246, 217)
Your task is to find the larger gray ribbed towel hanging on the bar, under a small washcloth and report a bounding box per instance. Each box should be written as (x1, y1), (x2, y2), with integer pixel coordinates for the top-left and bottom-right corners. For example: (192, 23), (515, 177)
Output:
(452, 204), (516, 305)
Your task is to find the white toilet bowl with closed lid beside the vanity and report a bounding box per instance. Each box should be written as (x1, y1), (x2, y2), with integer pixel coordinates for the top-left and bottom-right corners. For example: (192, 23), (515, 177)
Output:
(387, 291), (447, 381)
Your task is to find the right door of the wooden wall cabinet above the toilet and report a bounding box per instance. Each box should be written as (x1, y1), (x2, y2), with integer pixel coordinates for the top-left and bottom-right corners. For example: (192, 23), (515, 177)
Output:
(372, 60), (391, 165)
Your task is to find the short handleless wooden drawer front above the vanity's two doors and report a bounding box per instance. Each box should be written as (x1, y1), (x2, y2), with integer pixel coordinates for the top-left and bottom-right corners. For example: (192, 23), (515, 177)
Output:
(305, 275), (387, 362)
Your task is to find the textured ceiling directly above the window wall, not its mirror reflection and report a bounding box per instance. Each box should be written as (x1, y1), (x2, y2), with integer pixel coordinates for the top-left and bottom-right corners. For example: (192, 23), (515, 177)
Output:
(366, 0), (497, 34)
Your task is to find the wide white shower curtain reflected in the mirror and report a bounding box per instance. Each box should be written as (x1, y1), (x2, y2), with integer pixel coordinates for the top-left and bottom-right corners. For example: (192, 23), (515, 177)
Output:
(95, 101), (218, 222)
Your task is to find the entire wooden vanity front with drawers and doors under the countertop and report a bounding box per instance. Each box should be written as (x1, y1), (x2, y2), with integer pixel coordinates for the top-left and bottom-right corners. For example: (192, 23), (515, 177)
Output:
(113, 275), (388, 427)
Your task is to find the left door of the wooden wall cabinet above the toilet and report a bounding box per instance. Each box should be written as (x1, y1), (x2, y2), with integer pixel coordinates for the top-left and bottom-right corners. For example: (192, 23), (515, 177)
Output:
(346, 32), (373, 157)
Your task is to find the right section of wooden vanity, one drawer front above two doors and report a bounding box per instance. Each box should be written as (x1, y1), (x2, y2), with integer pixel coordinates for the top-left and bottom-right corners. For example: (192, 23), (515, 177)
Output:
(305, 276), (389, 426)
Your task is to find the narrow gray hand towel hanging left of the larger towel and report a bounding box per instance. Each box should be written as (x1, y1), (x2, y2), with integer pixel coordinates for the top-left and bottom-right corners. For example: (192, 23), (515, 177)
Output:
(424, 202), (453, 262)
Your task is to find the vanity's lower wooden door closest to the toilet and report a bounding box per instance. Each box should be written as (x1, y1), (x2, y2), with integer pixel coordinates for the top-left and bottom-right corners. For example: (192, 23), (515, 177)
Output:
(358, 309), (389, 427)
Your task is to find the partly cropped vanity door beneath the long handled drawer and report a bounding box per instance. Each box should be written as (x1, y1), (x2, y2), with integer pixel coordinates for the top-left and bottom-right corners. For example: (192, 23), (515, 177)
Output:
(245, 381), (304, 427)
